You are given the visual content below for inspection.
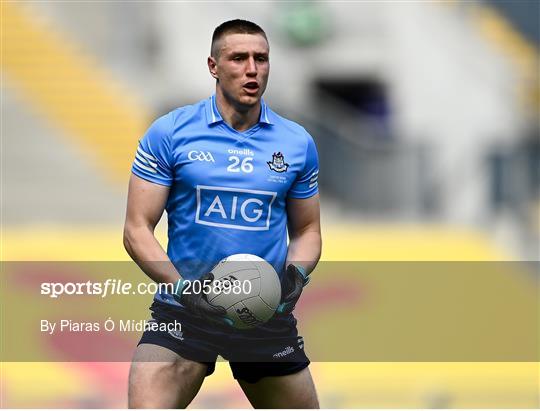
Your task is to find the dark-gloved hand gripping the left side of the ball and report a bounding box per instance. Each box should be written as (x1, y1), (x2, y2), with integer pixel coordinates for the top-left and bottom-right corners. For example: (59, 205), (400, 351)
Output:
(173, 273), (233, 325)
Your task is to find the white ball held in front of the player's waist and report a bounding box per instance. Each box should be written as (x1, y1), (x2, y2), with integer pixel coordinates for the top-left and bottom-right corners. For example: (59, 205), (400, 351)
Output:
(208, 254), (281, 329)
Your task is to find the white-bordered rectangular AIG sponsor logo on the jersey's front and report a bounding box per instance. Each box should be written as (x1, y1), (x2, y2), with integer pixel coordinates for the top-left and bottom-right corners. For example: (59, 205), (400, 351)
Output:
(195, 185), (277, 231)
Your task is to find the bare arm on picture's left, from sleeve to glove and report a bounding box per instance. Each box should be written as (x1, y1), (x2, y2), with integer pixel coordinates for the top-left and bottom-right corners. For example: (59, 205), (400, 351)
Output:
(124, 174), (180, 284)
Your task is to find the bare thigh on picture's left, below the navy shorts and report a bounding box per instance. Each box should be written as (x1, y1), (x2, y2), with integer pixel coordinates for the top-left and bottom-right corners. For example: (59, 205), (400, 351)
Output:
(128, 344), (208, 408)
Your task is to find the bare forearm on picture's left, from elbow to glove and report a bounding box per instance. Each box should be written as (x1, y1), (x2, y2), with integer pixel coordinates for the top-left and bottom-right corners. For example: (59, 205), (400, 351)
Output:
(124, 226), (180, 284)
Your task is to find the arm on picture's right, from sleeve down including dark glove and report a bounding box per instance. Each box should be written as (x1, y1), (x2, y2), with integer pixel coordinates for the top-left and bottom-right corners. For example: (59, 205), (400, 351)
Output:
(277, 194), (322, 314)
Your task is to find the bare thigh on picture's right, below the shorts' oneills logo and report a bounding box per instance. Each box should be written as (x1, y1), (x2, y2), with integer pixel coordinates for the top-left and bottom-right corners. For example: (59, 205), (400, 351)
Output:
(238, 367), (319, 408)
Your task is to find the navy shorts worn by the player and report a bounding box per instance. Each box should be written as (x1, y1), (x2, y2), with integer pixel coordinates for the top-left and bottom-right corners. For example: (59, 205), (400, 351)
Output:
(139, 301), (309, 383)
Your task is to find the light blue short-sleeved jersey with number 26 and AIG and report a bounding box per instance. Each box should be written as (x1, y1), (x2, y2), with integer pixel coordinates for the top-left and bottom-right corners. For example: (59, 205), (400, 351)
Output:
(132, 96), (319, 302)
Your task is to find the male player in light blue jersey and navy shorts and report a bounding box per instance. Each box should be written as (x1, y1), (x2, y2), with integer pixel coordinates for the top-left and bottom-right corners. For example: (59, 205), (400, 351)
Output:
(124, 20), (321, 408)
